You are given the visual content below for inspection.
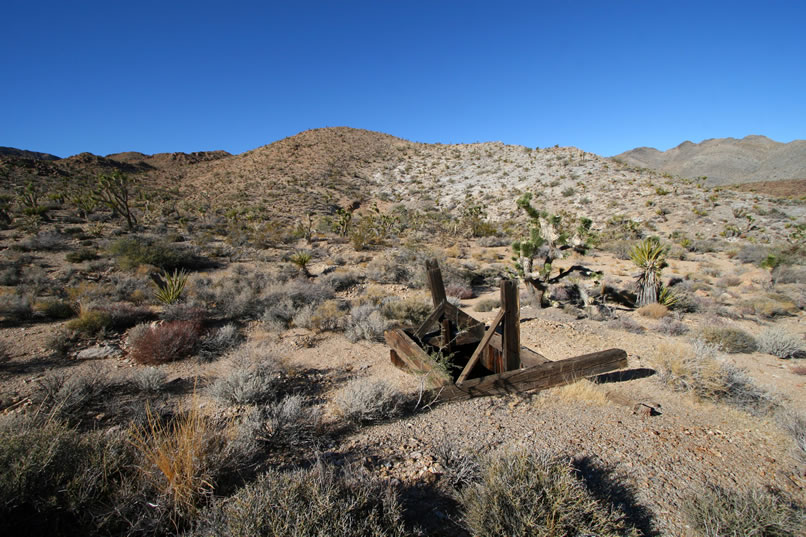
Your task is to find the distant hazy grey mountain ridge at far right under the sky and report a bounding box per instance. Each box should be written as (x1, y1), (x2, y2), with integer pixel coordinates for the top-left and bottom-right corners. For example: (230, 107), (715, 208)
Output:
(614, 135), (806, 186)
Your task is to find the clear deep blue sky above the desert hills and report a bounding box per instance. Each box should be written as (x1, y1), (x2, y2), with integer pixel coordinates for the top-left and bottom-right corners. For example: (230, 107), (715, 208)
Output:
(0, 0), (806, 157)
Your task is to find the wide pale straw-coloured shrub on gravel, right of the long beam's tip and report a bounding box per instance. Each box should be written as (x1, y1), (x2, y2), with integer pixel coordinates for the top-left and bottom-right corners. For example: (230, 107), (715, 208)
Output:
(654, 340), (776, 415)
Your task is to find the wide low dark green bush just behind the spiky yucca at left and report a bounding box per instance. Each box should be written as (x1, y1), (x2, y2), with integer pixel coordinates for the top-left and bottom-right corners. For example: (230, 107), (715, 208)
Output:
(109, 237), (210, 271)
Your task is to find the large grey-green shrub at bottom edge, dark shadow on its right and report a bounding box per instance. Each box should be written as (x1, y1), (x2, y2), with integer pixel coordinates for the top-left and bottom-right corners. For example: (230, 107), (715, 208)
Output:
(459, 453), (639, 537)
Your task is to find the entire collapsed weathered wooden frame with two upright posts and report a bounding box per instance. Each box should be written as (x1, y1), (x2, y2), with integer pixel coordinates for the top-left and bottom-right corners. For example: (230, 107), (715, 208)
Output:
(384, 260), (627, 401)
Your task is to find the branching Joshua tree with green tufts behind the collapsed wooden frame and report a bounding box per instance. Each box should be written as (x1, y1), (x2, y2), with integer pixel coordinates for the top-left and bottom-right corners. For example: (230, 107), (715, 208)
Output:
(512, 192), (596, 308)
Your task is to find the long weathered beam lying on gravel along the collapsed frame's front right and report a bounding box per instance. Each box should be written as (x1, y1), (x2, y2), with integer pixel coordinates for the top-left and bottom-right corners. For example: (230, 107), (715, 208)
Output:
(439, 349), (627, 401)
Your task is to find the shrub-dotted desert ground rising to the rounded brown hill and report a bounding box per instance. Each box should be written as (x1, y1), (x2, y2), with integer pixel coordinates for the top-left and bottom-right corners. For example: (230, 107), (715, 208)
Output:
(0, 127), (806, 537)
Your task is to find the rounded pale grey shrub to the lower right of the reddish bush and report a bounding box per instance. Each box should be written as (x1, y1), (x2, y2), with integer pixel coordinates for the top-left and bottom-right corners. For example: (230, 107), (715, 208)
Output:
(210, 346), (282, 405)
